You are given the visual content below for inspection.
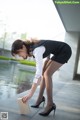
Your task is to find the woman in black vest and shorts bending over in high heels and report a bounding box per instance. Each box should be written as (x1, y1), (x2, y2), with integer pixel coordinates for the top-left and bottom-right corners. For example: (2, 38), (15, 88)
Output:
(11, 40), (72, 116)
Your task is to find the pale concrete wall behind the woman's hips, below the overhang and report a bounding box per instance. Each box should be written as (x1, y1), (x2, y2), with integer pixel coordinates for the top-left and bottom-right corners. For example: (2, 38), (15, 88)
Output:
(60, 32), (79, 80)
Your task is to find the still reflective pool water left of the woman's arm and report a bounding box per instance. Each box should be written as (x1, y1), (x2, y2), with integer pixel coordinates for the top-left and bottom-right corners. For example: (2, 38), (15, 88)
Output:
(0, 60), (35, 99)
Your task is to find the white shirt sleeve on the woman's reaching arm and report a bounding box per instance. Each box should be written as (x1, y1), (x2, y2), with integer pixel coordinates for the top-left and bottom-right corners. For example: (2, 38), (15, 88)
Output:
(33, 46), (45, 83)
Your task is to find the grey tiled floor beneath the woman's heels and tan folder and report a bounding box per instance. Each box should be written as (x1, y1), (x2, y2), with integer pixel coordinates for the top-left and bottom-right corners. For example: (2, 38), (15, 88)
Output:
(0, 72), (80, 120)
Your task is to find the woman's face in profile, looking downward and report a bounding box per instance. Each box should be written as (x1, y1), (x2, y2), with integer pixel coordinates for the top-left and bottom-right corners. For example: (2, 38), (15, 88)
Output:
(14, 45), (29, 59)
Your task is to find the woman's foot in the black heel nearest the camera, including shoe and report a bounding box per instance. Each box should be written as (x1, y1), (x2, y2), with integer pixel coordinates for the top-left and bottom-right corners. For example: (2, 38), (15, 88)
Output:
(39, 103), (56, 116)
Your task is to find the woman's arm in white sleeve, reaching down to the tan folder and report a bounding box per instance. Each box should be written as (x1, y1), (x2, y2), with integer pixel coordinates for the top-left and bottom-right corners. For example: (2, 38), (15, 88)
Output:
(22, 47), (45, 103)
